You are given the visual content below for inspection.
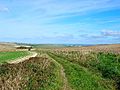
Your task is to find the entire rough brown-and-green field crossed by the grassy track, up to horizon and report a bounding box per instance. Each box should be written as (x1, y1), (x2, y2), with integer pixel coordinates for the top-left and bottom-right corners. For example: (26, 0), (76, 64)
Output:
(0, 45), (120, 90)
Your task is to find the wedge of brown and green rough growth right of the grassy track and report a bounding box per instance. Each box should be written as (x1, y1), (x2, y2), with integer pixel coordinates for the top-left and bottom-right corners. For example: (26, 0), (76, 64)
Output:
(48, 51), (120, 90)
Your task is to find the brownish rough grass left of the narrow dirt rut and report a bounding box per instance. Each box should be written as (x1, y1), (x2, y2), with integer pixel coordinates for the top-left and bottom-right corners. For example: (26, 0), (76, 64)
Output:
(0, 57), (63, 90)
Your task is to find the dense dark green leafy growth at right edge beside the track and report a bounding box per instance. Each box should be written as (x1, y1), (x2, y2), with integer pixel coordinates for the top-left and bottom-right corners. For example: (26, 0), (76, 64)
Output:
(87, 53), (120, 90)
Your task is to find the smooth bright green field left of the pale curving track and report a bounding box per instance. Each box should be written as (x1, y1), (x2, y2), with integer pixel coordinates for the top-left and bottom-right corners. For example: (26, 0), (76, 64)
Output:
(0, 51), (29, 63)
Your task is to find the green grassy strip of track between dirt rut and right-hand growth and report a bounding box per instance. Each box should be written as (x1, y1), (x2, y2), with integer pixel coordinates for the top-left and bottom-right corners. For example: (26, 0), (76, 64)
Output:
(49, 53), (114, 90)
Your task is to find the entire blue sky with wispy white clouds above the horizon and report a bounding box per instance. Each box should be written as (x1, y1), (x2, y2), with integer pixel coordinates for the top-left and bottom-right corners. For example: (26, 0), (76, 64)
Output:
(0, 0), (120, 44)
